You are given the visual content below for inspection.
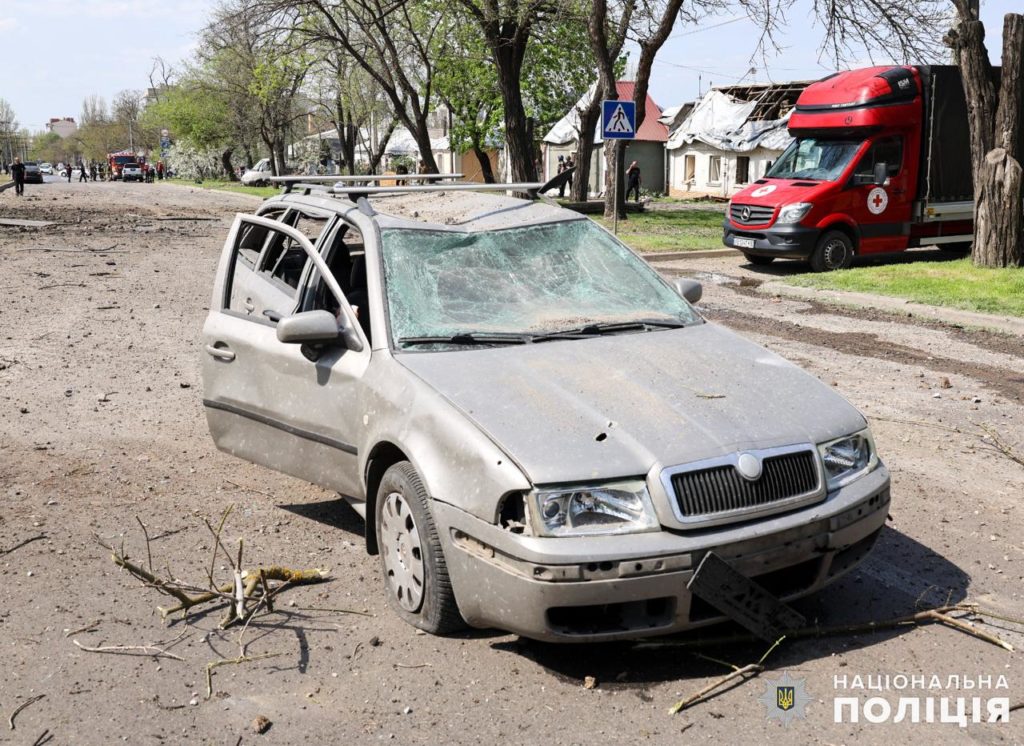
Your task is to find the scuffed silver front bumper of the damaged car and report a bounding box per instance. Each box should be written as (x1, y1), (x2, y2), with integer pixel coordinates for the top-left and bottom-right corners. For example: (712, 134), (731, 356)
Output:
(433, 465), (890, 642)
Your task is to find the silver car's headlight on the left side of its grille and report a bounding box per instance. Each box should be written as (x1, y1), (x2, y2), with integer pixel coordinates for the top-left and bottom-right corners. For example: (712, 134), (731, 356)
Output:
(529, 479), (658, 536)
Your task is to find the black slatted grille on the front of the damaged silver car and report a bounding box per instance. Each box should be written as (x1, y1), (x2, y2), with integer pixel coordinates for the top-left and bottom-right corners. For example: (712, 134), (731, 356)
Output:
(672, 450), (819, 519)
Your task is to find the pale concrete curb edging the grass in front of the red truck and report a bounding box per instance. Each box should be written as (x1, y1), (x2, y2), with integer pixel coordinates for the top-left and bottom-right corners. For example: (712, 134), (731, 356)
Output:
(758, 280), (1024, 337)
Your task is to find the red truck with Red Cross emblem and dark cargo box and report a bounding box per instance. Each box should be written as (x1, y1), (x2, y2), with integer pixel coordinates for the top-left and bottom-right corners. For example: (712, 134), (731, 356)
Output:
(723, 67), (974, 271)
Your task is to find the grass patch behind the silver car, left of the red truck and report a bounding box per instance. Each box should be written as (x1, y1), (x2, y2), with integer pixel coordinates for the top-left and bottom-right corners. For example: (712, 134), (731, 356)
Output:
(595, 209), (724, 253)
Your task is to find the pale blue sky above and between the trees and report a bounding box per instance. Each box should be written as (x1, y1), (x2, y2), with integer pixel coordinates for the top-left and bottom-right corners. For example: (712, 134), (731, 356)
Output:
(0, 0), (1020, 130)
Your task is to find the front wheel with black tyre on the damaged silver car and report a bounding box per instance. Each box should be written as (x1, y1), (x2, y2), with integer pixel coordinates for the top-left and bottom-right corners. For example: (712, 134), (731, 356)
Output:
(376, 462), (466, 634)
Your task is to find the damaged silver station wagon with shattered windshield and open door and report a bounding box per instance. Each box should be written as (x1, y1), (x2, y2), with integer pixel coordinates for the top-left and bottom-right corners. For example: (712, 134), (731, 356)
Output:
(203, 179), (890, 642)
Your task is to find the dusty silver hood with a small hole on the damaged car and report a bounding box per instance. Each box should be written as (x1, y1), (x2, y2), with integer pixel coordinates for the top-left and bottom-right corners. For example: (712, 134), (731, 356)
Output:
(396, 323), (864, 484)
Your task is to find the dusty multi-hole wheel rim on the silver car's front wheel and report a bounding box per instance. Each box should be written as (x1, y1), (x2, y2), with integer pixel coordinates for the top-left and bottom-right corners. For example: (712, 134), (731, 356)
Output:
(381, 492), (424, 613)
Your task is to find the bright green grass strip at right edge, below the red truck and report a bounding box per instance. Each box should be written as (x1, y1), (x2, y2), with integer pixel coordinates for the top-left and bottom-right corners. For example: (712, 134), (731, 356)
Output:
(786, 258), (1024, 316)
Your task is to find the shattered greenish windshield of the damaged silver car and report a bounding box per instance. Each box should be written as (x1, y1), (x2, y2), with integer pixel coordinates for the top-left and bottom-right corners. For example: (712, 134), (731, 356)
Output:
(381, 220), (699, 347)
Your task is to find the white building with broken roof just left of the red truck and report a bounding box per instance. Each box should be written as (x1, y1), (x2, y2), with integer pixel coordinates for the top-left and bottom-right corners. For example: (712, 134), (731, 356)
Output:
(666, 82), (808, 198)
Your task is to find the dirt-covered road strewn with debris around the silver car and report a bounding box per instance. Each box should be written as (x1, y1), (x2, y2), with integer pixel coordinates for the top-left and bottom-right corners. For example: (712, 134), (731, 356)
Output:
(0, 183), (1024, 744)
